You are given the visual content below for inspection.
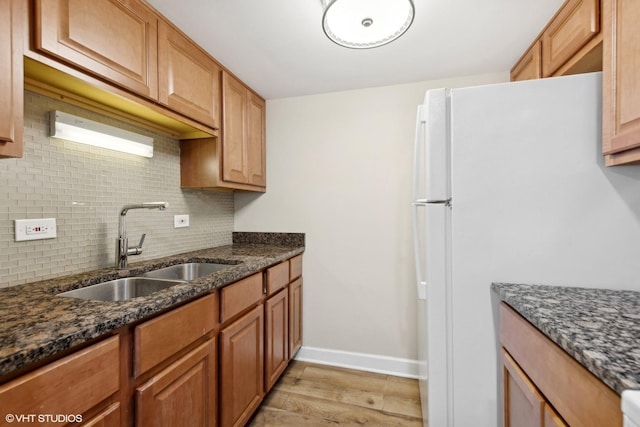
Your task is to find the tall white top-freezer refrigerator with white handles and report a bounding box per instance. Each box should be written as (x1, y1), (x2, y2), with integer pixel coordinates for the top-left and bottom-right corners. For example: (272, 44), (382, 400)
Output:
(413, 73), (640, 427)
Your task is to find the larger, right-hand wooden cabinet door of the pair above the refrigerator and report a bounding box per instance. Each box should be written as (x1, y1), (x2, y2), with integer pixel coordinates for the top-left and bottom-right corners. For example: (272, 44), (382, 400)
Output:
(542, 0), (600, 76)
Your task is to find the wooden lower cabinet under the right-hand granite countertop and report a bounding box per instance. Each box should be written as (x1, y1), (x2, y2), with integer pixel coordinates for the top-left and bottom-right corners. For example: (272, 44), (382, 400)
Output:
(500, 303), (622, 427)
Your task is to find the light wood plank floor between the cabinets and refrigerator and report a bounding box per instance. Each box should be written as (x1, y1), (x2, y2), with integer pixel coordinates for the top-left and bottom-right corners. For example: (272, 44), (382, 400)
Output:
(248, 360), (422, 427)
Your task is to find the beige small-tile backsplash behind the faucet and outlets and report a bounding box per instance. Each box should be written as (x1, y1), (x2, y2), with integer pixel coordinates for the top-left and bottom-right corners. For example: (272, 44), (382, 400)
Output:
(0, 91), (234, 287)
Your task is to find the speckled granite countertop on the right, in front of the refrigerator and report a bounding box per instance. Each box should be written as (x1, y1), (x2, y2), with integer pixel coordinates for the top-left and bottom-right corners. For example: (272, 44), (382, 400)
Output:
(491, 283), (640, 394)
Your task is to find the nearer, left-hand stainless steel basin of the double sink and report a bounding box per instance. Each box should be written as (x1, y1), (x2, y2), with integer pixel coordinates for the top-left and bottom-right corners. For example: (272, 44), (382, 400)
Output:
(58, 277), (185, 301)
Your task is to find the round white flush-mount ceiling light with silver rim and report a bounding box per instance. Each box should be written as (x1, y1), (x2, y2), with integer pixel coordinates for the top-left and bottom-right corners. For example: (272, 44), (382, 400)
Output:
(322, 0), (415, 49)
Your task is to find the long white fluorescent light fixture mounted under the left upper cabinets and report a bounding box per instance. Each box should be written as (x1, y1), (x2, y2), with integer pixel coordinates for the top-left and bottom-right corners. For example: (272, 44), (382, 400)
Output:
(49, 110), (153, 157)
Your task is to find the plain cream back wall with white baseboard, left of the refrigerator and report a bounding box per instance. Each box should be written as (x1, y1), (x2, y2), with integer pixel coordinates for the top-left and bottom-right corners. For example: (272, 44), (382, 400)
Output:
(235, 73), (508, 374)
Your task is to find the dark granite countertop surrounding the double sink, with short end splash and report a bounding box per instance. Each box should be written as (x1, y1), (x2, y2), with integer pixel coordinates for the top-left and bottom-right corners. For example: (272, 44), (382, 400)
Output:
(0, 233), (304, 377)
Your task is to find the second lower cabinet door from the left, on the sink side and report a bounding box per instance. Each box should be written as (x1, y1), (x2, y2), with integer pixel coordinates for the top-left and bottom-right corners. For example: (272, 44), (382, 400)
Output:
(220, 305), (264, 427)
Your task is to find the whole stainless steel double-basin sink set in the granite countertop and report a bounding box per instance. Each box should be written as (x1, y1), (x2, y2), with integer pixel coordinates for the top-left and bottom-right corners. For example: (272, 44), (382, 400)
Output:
(57, 262), (234, 301)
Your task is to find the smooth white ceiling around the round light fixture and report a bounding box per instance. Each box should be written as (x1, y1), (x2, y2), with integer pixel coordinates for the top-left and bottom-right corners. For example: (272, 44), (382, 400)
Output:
(148, 0), (563, 99)
